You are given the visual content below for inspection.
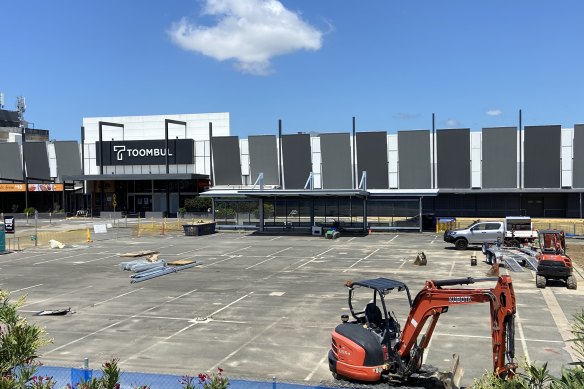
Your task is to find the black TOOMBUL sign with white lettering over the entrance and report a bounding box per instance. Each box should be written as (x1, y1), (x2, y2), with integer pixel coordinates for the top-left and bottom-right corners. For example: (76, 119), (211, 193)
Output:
(95, 139), (194, 166)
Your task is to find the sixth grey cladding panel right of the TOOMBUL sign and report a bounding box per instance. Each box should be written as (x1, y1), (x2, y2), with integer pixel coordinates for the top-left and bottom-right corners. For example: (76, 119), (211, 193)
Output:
(397, 130), (432, 189)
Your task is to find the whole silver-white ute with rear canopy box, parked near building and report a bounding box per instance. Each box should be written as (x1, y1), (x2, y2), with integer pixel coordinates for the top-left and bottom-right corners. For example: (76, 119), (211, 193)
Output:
(444, 216), (537, 250)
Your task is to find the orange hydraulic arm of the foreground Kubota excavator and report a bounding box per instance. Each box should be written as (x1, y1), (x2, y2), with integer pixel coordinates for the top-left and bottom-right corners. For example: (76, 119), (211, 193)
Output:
(397, 275), (517, 377)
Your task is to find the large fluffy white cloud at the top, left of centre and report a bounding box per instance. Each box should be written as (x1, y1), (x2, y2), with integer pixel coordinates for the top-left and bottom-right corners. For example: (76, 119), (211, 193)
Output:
(168, 0), (323, 75)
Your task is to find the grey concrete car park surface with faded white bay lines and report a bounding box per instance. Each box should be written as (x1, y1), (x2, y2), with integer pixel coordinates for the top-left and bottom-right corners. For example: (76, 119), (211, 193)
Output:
(0, 228), (584, 385)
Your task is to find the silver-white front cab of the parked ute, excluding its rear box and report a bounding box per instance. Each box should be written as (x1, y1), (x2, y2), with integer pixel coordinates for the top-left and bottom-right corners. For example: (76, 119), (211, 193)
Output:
(444, 220), (505, 250)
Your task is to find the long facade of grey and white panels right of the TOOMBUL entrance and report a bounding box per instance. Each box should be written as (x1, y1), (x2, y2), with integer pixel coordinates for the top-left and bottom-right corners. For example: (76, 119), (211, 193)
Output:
(205, 125), (584, 229)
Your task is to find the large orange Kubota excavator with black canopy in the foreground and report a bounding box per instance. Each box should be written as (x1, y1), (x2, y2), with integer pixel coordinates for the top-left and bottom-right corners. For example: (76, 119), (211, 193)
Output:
(328, 276), (517, 382)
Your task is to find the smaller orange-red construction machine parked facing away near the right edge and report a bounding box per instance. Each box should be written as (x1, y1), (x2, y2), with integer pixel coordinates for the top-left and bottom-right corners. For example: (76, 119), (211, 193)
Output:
(535, 230), (578, 289)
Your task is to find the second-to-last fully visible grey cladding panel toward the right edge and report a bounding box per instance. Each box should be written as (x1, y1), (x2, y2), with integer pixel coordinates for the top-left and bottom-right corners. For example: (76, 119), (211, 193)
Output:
(482, 127), (517, 188)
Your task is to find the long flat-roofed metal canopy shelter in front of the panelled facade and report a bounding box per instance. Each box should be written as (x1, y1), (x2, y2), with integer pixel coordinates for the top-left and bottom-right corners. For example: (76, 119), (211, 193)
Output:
(201, 188), (436, 233)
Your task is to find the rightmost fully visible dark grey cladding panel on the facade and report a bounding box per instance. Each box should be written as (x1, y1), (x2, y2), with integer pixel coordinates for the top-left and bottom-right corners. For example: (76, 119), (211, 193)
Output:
(523, 126), (562, 188)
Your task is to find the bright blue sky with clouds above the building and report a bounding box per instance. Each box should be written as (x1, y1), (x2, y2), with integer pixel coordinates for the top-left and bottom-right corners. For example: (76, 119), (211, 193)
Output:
(0, 0), (584, 140)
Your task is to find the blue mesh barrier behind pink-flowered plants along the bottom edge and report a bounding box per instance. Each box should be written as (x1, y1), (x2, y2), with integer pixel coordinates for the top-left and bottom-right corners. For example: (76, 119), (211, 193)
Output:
(37, 366), (328, 389)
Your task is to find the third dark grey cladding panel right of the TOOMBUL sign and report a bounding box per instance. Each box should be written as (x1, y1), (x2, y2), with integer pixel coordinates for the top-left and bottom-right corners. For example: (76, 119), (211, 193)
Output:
(282, 134), (312, 189)
